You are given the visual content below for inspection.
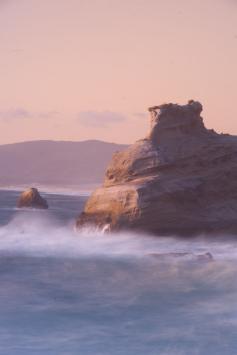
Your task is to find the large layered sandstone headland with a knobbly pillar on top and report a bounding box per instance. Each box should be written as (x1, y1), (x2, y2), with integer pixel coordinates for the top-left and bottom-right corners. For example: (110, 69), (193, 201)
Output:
(77, 101), (237, 235)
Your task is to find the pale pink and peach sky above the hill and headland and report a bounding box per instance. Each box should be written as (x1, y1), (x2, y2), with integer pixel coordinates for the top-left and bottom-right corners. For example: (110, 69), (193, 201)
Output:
(0, 0), (237, 144)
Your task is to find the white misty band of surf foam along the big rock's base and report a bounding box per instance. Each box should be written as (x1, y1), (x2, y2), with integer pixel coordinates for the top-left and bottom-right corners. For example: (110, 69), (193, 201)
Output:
(0, 211), (237, 260)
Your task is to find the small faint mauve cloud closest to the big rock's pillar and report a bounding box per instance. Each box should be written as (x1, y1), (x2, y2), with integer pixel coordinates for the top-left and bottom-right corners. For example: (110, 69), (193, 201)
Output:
(77, 111), (127, 127)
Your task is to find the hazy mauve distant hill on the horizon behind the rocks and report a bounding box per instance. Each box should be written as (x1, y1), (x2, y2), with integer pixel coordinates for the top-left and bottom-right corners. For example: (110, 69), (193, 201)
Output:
(0, 140), (127, 186)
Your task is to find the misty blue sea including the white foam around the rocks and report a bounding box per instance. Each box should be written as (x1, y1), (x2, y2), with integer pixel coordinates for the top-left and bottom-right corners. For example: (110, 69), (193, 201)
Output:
(0, 191), (237, 355)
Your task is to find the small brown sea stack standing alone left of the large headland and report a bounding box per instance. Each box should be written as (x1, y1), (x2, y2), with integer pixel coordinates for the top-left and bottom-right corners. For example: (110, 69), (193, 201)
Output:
(17, 187), (48, 209)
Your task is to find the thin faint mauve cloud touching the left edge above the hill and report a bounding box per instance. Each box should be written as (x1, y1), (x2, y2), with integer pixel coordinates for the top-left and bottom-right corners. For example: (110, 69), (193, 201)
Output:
(0, 108), (58, 122)
